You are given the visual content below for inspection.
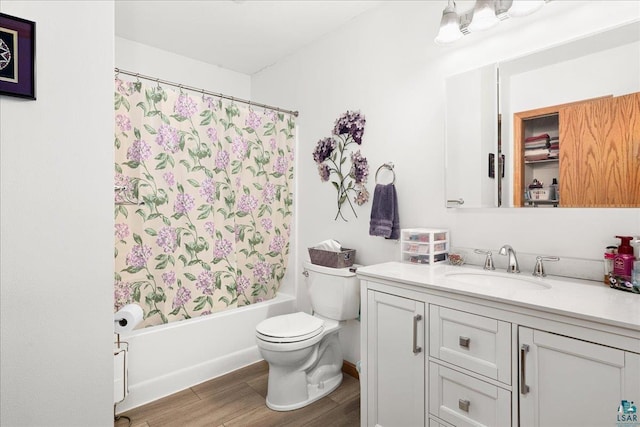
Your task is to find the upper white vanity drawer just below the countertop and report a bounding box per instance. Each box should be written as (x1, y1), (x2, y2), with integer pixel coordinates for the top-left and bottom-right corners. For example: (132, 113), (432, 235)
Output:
(429, 305), (511, 384)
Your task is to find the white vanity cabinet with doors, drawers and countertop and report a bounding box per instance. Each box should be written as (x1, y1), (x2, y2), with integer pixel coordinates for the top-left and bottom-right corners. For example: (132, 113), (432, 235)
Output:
(358, 263), (640, 427)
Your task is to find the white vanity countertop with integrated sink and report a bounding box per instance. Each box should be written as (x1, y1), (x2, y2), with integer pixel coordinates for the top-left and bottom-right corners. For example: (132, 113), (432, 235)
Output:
(357, 262), (640, 331)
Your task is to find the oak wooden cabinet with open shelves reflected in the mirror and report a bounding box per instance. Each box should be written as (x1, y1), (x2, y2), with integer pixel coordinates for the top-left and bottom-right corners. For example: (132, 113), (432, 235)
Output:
(514, 93), (640, 207)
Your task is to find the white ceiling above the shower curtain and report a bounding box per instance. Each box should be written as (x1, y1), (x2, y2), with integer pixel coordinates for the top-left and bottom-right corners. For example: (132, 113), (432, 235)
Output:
(115, 0), (384, 75)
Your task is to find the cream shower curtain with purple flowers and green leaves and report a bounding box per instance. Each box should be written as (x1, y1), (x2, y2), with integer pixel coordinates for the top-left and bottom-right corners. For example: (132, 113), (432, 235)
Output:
(114, 79), (295, 326)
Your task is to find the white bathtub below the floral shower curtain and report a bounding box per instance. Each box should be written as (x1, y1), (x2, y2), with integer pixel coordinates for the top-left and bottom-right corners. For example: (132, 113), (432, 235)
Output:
(115, 294), (296, 413)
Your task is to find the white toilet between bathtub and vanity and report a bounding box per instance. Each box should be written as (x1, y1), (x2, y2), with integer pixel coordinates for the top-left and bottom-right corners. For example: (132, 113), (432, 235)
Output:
(256, 262), (360, 411)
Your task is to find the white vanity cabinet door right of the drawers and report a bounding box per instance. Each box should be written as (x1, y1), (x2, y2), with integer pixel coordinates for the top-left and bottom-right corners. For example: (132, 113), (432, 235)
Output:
(518, 327), (640, 427)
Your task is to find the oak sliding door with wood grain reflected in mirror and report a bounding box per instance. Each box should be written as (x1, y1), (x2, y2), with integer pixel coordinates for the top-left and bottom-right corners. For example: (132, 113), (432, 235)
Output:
(559, 93), (640, 207)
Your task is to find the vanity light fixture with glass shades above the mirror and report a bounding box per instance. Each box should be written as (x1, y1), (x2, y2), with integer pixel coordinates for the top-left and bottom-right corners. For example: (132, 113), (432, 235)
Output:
(435, 0), (551, 44)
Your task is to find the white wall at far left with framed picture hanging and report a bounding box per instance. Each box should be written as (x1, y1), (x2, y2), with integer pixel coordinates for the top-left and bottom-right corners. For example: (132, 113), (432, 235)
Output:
(0, 0), (114, 427)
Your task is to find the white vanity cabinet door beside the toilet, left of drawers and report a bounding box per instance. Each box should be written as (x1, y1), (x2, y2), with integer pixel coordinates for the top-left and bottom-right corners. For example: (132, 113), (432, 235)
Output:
(366, 290), (426, 427)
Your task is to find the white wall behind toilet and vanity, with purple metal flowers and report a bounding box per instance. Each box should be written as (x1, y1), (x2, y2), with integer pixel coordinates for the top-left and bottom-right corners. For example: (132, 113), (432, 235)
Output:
(252, 0), (640, 366)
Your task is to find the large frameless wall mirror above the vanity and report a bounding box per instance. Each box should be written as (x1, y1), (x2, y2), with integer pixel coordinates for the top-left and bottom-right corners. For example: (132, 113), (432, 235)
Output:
(445, 22), (640, 208)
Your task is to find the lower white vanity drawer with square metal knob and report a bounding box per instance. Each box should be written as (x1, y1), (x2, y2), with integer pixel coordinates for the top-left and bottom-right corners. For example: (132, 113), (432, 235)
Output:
(429, 362), (511, 427)
